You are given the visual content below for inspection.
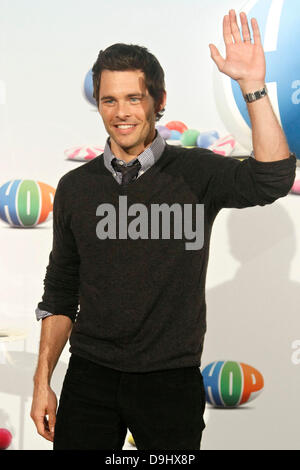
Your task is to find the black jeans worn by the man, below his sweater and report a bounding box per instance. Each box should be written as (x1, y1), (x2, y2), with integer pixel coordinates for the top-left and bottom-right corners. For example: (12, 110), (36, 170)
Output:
(53, 354), (205, 450)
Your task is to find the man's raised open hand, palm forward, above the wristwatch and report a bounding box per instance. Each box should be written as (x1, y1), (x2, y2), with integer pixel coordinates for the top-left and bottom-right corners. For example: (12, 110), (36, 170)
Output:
(209, 10), (266, 92)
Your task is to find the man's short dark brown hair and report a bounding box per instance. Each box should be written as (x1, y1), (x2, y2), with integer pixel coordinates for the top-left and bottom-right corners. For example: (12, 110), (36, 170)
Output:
(92, 43), (165, 121)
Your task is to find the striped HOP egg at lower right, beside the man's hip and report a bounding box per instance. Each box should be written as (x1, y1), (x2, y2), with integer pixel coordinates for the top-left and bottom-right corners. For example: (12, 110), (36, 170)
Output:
(202, 361), (264, 408)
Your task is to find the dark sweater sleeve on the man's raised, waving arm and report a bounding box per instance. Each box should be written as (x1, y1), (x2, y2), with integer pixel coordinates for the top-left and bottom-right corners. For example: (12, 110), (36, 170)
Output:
(208, 155), (296, 209)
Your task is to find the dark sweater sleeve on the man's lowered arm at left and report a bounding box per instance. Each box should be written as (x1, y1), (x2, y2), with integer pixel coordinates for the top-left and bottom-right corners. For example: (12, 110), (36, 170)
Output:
(36, 176), (80, 322)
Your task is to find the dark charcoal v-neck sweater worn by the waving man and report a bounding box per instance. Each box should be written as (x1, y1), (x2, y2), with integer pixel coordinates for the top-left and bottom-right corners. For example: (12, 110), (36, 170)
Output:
(38, 145), (296, 372)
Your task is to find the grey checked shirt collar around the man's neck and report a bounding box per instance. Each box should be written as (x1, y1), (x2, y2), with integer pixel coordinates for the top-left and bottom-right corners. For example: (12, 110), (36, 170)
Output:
(104, 131), (166, 173)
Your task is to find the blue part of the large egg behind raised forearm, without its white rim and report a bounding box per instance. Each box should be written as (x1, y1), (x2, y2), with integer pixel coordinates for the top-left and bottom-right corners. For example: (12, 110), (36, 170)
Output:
(231, 0), (300, 158)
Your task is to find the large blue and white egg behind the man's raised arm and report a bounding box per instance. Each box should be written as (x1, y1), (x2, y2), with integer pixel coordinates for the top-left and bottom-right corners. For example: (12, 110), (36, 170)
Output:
(215, 0), (300, 159)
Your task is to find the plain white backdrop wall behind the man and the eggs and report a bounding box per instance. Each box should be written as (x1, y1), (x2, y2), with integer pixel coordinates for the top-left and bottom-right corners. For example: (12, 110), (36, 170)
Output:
(0, 0), (300, 450)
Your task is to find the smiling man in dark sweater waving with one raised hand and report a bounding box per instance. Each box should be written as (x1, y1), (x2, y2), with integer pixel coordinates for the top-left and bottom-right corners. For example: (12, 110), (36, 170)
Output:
(31, 10), (296, 450)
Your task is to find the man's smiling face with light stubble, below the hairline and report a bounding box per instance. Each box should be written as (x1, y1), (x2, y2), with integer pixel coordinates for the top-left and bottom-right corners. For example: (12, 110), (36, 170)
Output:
(99, 70), (164, 158)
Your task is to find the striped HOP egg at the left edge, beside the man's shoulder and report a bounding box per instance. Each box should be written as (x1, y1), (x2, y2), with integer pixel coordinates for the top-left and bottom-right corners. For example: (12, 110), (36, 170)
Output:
(0, 179), (55, 227)
